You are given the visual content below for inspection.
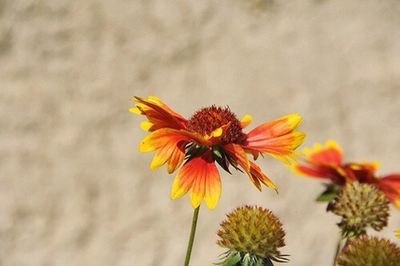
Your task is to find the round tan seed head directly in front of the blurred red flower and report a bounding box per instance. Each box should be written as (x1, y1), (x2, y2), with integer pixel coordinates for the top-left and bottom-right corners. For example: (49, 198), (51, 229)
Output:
(327, 182), (389, 237)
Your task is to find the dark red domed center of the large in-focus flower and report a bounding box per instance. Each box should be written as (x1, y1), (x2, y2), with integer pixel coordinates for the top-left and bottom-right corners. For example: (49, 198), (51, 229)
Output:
(186, 105), (246, 143)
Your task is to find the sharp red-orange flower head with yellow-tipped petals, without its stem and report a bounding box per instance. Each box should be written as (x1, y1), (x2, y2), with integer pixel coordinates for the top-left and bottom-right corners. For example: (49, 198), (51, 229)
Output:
(130, 96), (305, 209)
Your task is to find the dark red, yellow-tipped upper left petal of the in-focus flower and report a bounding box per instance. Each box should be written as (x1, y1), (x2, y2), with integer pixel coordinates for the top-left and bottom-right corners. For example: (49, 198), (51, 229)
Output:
(129, 96), (187, 131)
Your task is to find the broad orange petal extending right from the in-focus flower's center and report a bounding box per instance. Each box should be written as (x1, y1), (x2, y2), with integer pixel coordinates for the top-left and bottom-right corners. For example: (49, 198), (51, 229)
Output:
(243, 114), (305, 162)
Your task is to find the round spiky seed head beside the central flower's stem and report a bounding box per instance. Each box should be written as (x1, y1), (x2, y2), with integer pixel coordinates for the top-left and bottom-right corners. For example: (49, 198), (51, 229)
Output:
(217, 206), (287, 266)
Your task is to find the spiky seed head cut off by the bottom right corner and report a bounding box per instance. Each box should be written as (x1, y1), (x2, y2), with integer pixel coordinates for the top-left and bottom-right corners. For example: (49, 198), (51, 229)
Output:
(336, 236), (400, 266)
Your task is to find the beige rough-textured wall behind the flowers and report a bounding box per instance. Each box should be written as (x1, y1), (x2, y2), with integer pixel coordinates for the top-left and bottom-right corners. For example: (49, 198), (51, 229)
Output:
(0, 0), (400, 266)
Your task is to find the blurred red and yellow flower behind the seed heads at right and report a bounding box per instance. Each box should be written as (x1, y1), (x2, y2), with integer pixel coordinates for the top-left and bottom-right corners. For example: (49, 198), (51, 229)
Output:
(291, 140), (400, 208)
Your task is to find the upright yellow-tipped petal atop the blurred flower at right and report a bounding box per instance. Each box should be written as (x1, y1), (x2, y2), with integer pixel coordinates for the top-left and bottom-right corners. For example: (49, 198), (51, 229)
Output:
(304, 140), (342, 166)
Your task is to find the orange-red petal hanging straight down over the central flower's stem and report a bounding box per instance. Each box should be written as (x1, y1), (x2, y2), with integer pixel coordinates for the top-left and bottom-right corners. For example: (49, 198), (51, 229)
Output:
(171, 151), (221, 209)
